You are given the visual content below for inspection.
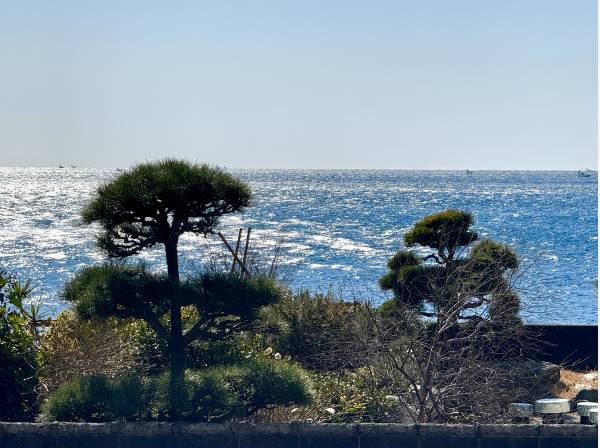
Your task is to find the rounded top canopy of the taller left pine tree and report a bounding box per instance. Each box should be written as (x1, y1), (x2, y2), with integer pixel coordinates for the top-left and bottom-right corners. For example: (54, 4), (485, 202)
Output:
(83, 159), (251, 257)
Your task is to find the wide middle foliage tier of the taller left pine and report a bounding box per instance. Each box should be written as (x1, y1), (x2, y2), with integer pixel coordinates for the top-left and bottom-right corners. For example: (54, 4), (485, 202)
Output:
(63, 263), (287, 348)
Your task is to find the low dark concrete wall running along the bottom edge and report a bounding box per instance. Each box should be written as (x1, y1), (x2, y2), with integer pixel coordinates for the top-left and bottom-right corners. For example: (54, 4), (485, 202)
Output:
(0, 423), (598, 448)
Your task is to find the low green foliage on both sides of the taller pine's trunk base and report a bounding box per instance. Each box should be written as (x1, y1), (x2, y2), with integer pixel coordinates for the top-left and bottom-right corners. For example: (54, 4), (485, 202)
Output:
(40, 355), (312, 422)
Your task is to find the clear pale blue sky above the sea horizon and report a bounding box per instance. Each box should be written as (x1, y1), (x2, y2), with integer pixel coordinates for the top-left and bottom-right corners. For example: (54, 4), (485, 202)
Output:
(0, 0), (597, 169)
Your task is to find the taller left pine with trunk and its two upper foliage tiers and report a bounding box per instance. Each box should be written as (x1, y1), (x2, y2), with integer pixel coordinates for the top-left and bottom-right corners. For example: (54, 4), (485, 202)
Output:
(63, 159), (284, 418)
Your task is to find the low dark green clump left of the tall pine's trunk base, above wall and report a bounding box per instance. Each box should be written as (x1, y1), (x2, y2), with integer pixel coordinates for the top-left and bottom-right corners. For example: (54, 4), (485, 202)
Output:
(40, 375), (147, 422)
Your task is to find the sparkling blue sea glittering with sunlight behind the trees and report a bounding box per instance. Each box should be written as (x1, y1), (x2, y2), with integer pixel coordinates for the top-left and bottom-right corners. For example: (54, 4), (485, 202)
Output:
(0, 168), (598, 324)
